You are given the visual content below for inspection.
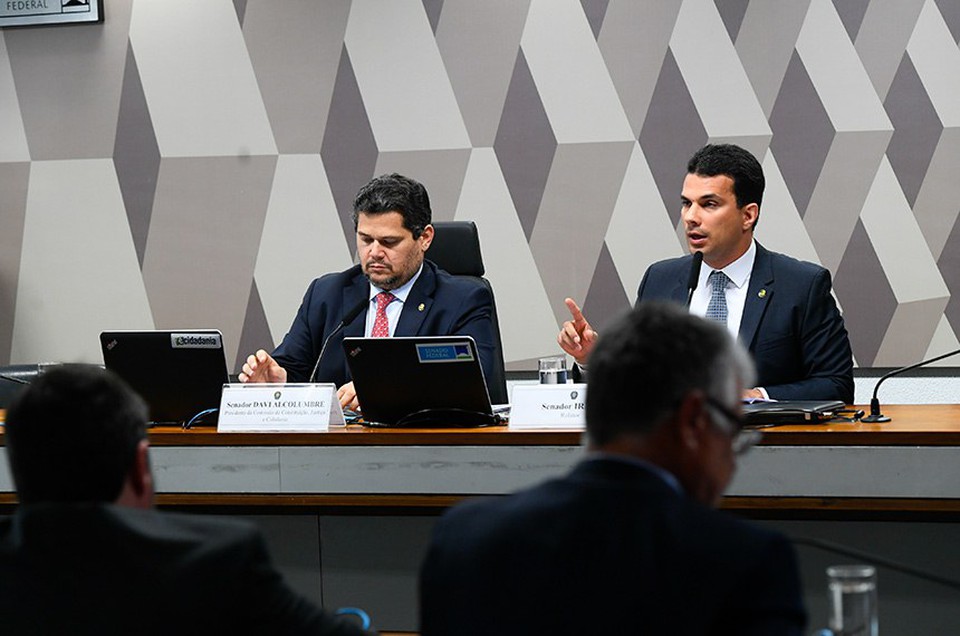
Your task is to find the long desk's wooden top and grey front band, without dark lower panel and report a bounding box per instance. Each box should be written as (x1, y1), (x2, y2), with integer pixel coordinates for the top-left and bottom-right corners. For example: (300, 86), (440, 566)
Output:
(7, 405), (960, 513)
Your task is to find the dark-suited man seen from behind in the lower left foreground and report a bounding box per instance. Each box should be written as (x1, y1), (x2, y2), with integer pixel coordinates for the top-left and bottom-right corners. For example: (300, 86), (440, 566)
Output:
(0, 367), (366, 636)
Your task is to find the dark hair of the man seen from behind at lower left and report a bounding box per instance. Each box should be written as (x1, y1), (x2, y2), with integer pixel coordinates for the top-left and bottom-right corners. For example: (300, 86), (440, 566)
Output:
(6, 365), (148, 504)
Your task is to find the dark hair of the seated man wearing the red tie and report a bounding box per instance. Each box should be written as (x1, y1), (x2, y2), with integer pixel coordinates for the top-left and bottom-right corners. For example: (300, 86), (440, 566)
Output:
(353, 173), (433, 238)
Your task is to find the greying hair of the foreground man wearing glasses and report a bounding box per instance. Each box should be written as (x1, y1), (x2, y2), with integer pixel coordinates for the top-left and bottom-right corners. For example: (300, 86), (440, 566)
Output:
(586, 301), (753, 445)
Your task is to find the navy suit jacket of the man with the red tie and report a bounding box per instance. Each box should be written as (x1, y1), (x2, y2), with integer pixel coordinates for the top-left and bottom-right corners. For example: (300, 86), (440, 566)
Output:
(273, 260), (494, 386)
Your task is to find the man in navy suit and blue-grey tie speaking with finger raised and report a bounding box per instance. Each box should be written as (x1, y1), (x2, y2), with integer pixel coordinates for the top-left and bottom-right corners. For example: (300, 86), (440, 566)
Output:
(557, 144), (853, 403)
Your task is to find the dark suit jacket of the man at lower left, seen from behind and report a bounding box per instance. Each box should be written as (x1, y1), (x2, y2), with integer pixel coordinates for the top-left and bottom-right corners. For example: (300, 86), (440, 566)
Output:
(0, 504), (365, 636)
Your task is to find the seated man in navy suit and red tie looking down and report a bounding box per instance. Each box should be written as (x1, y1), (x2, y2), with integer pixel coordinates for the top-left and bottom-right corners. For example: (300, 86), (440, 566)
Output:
(240, 174), (494, 408)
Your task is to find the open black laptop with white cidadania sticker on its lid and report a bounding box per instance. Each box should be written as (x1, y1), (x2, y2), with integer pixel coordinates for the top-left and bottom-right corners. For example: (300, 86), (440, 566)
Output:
(100, 329), (228, 424)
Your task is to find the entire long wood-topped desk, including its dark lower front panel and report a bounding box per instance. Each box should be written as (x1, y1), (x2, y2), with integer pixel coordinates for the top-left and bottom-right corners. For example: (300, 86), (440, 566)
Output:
(0, 405), (960, 633)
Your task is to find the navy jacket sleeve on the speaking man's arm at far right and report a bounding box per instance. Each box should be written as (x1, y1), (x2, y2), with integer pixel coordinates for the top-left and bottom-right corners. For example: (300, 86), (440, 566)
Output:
(763, 269), (853, 404)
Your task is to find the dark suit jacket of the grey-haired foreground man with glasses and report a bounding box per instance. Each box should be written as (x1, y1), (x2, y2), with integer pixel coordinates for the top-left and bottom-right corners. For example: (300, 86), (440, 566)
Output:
(420, 458), (806, 636)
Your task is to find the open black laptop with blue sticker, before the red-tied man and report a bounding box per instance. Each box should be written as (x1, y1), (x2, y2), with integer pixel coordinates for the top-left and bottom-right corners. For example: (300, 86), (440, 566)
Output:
(343, 336), (497, 427)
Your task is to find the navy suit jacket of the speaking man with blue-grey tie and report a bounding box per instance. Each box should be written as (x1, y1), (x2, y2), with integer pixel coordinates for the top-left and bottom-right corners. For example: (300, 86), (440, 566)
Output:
(637, 243), (853, 404)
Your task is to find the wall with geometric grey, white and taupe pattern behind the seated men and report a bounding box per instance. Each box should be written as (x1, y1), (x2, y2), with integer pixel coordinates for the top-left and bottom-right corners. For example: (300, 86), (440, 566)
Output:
(0, 0), (960, 368)
